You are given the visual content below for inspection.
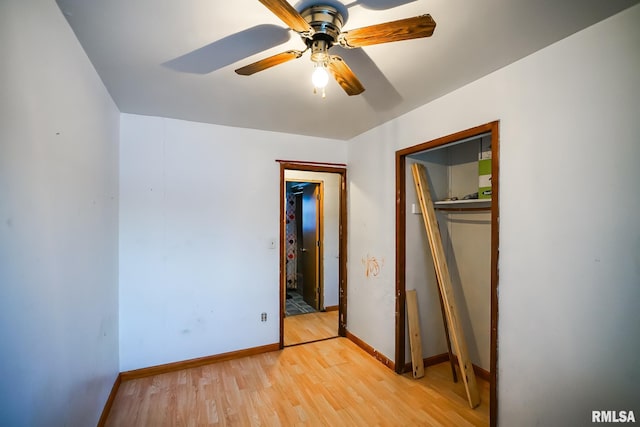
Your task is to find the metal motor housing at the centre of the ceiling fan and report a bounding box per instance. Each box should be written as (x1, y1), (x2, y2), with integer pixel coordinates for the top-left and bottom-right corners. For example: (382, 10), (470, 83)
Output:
(301, 5), (344, 62)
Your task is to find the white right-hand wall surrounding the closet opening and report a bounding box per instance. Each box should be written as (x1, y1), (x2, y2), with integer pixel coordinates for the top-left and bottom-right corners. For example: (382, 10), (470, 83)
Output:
(348, 6), (640, 426)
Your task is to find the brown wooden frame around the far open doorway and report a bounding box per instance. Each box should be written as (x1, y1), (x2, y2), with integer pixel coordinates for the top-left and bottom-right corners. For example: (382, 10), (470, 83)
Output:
(278, 160), (347, 349)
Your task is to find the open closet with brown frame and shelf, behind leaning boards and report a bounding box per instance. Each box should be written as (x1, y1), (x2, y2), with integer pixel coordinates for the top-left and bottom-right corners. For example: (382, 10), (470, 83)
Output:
(395, 121), (499, 426)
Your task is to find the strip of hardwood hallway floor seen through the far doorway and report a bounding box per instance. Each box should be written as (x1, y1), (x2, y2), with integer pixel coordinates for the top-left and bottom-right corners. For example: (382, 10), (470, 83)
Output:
(284, 310), (338, 346)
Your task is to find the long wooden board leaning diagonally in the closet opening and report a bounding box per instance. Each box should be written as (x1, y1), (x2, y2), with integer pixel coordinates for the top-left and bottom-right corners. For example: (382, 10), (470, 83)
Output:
(411, 163), (480, 408)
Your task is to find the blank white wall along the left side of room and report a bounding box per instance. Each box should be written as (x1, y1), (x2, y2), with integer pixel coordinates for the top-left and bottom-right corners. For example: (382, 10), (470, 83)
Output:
(0, 0), (119, 426)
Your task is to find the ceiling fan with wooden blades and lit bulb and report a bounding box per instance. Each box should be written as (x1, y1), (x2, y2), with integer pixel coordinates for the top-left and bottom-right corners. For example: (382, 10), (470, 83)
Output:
(235, 0), (436, 97)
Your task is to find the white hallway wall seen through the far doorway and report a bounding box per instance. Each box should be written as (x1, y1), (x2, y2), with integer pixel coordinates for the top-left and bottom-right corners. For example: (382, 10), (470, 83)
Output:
(285, 170), (342, 307)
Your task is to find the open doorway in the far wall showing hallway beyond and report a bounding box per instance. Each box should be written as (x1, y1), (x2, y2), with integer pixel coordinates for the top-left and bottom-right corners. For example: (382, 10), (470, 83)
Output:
(280, 162), (346, 347)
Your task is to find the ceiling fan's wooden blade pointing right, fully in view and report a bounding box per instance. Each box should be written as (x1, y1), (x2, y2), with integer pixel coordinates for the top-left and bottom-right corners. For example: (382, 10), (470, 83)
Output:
(338, 15), (436, 47)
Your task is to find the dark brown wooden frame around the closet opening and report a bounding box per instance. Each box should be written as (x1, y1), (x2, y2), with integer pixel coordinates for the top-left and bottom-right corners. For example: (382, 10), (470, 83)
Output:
(395, 120), (500, 427)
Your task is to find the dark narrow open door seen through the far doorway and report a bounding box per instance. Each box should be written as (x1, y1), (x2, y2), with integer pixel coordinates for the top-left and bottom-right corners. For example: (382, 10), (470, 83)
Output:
(302, 184), (320, 310)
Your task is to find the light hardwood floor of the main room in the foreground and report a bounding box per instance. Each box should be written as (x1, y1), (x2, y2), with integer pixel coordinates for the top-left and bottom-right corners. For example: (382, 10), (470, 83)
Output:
(106, 338), (489, 427)
